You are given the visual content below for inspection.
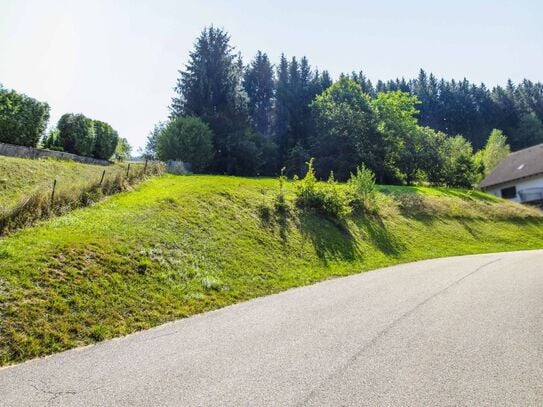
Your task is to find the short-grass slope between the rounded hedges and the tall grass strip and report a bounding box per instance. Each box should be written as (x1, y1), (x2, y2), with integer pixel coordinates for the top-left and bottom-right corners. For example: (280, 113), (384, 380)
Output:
(0, 156), (132, 210)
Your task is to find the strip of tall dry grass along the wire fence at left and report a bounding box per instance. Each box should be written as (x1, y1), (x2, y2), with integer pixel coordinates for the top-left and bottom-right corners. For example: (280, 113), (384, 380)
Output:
(0, 163), (164, 236)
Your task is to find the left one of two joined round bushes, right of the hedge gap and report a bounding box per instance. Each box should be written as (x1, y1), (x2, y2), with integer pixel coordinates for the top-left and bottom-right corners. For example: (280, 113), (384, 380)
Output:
(57, 113), (95, 157)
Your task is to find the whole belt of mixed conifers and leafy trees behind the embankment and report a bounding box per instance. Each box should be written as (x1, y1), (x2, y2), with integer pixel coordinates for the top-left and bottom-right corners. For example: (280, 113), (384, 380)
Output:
(146, 27), (543, 187)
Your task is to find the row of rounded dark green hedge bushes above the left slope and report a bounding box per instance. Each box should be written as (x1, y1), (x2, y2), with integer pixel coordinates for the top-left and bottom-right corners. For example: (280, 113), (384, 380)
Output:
(0, 85), (126, 160)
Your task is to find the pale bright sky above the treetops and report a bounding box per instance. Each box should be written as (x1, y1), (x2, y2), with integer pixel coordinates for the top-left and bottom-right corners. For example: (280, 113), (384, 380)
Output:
(0, 0), (543, 153)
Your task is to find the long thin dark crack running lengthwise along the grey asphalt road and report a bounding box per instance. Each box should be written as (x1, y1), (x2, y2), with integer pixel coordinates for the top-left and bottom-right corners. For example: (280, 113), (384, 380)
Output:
(296, 257), (502, 406)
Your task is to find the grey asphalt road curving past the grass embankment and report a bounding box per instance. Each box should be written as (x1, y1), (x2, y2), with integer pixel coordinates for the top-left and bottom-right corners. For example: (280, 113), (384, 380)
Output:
(0, 251), (543, 406)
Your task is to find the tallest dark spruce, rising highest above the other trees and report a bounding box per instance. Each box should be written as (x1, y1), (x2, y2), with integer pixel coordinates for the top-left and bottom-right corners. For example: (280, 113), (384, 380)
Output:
(170, 27), (251, 173)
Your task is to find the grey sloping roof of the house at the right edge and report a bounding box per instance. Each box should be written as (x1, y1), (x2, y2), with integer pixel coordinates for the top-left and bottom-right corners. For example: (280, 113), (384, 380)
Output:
(479, 144), (543, 188)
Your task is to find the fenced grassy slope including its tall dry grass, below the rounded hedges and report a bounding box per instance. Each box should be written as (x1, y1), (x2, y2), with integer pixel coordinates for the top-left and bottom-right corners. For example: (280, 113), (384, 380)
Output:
(0, 157), (160, 235)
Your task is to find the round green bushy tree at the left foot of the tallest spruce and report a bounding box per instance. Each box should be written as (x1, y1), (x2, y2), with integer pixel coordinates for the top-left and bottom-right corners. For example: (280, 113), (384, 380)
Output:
(156, 117), (213, 172)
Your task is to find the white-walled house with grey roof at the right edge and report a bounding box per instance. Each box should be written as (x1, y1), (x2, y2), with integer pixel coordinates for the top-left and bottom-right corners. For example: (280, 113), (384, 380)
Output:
(479, 144), (543, 208)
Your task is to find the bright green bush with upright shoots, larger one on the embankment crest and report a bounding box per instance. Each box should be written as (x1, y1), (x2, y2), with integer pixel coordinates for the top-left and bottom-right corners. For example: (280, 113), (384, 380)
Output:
(296, 158), (350, 218)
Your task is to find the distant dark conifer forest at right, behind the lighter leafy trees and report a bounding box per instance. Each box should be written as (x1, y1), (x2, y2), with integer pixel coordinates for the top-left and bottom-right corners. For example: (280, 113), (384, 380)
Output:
(360, 70), (543, 151)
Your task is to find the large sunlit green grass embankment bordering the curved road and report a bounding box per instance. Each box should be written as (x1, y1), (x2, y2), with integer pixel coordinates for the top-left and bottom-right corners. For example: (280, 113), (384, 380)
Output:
(0, 176), (543, 364)
